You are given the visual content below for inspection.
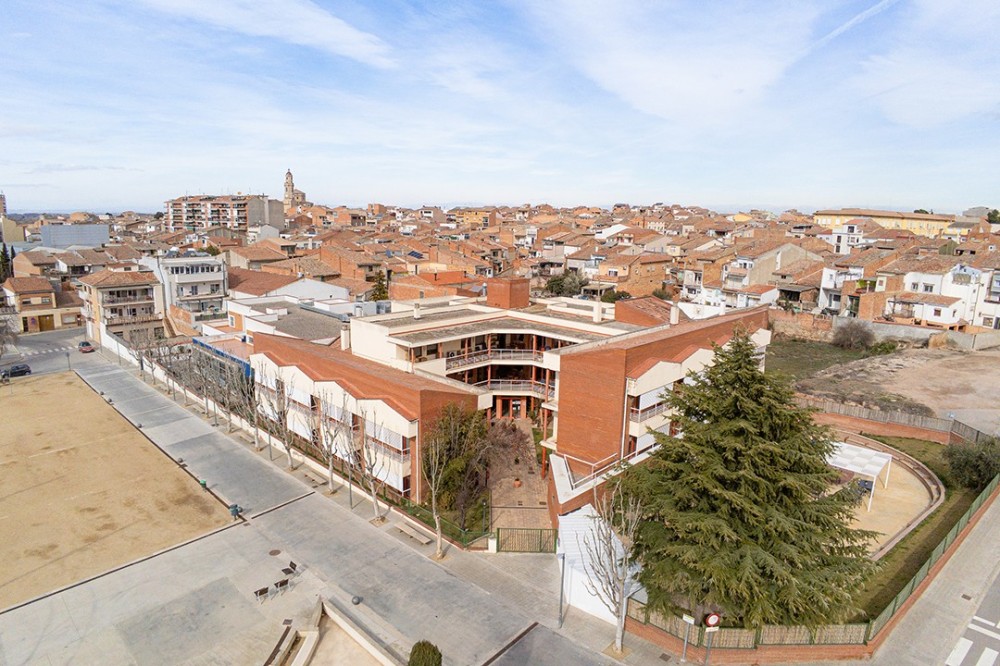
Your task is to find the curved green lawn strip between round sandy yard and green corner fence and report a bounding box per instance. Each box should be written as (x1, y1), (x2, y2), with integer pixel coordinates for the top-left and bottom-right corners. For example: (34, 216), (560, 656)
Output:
(858, 433), (979, 620)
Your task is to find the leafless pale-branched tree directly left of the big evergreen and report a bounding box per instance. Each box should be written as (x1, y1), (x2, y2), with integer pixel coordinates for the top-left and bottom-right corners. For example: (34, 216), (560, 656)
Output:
(578, 484), (643, 654)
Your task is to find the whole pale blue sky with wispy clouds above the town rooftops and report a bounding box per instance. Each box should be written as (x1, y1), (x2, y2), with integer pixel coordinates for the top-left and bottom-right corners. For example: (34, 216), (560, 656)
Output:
(0, 0), (1000, 212)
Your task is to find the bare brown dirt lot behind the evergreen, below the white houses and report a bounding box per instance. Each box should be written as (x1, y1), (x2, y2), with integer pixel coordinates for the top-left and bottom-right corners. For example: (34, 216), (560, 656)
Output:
(796, 349), (1000, 425)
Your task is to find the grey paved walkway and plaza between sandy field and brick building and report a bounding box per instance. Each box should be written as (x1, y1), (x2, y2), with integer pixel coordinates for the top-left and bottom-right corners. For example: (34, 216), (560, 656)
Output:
(0, 365), (640, 666)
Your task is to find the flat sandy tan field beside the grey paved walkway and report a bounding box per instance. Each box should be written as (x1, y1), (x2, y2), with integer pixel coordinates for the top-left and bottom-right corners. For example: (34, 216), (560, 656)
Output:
(0, 373), (231, 608)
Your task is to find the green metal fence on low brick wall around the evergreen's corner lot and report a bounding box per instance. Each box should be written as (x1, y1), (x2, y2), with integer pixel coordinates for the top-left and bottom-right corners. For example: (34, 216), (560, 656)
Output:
(628, 476), (1000, 649)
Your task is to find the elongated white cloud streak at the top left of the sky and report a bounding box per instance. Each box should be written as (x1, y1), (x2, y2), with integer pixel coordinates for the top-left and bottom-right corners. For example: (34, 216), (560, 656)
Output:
(141, 0), (397, 68)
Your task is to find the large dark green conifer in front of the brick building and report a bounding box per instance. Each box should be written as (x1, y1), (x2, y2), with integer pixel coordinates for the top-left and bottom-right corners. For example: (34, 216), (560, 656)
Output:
(622, 332), (874, 628)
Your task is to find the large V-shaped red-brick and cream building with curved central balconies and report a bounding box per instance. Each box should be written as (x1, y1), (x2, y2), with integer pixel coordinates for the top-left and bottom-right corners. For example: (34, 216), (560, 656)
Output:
(251, 279), (770, 519)
